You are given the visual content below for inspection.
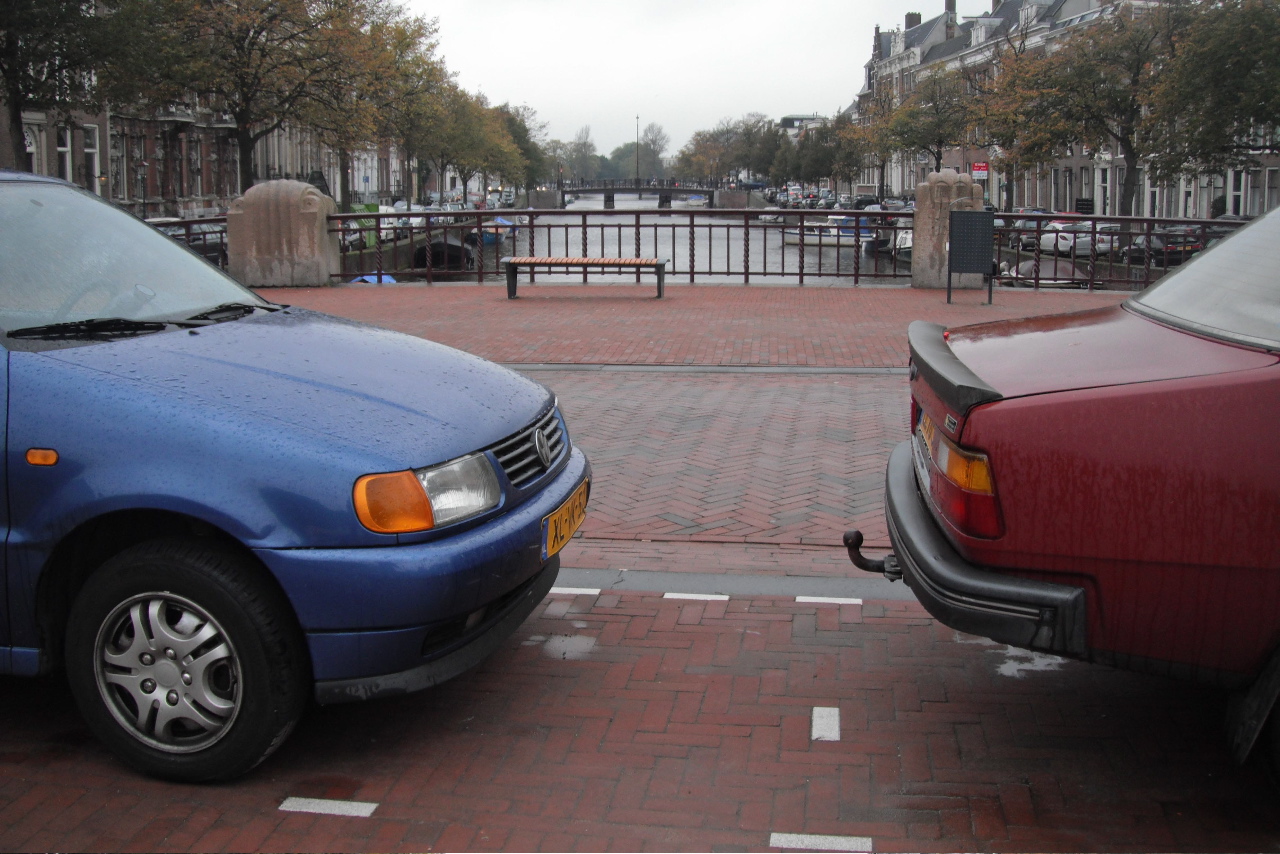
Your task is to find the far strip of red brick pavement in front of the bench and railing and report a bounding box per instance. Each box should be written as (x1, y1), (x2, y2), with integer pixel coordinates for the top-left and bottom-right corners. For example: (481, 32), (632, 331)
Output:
(262, 284), (1126, 367)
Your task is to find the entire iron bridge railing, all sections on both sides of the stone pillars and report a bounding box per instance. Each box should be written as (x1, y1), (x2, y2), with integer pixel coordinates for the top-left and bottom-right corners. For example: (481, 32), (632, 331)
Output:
(154, 209), (1243, 291)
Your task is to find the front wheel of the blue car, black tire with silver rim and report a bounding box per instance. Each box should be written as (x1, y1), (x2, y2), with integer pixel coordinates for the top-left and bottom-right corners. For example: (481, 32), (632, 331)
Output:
(65, 539), (311, 782)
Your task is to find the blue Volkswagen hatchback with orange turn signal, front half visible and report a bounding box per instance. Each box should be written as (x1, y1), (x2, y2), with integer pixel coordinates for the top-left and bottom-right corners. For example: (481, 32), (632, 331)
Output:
(0, 172), (591, 781)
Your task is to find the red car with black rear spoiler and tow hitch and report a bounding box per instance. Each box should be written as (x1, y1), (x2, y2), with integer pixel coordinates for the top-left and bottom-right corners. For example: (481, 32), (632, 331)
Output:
(845, 210), (1280, 764)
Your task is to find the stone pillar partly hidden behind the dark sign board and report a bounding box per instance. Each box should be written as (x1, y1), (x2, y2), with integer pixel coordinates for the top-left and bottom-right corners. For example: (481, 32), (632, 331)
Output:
(911, 169), (983, 288)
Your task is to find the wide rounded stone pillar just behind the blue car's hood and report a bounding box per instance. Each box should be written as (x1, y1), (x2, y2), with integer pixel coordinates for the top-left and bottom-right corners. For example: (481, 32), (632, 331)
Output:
(227, 181), (342, 288)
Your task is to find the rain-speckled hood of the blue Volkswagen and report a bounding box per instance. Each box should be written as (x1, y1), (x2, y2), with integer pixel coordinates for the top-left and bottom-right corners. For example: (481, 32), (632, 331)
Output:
(45, 309), (552, 469)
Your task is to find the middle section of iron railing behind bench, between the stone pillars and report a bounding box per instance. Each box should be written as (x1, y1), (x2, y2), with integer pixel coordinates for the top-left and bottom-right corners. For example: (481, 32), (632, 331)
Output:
(330, 209), (911, 286)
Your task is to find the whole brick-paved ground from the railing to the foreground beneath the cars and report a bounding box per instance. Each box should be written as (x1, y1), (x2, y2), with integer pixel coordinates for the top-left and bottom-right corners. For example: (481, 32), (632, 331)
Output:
(0, 284), (1280, 851)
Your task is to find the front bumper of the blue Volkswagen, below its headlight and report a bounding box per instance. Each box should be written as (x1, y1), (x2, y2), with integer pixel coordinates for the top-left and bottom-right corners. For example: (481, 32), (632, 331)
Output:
(256, 448), (591, 703)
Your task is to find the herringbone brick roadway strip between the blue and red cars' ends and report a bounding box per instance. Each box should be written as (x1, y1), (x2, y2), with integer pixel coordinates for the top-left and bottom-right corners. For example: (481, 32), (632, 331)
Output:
(560, 373), (909, 547)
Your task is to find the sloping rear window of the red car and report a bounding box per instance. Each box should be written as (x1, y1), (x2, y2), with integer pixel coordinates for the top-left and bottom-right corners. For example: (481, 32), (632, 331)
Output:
(1129, 209), (1280, 350)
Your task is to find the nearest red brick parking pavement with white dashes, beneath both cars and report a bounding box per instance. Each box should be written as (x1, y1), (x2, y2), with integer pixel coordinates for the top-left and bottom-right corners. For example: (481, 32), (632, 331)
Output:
(0, 594), (1280, 851)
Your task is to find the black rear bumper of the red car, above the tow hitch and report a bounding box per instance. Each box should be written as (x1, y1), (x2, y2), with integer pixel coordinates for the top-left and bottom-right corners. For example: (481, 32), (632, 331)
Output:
(884, 442), (1088, 658)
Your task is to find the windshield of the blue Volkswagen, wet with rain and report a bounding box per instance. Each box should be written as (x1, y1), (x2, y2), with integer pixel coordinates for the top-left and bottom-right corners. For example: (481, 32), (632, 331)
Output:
(0, 181), (263, 333)
